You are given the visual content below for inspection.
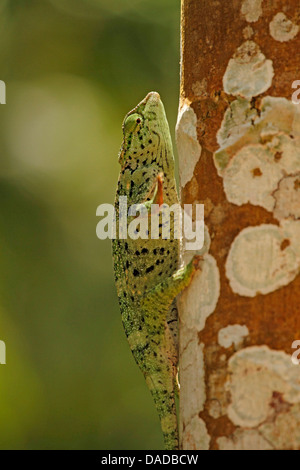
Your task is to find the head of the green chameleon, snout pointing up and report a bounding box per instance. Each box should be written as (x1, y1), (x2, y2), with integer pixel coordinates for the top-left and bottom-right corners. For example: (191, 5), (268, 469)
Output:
(119, 92), (172, 165)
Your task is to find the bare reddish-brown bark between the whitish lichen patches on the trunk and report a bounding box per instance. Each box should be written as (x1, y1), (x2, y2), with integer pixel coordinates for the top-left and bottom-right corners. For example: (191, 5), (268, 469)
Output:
(180, 0), (300, 449)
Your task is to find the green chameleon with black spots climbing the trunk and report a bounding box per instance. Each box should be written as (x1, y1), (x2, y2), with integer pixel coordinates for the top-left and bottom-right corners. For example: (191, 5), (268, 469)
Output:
(113, 92), (200, 449)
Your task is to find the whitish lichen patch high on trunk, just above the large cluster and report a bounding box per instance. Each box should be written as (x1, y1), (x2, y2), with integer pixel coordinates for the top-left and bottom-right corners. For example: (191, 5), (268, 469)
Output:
(223, 41), (274, 100)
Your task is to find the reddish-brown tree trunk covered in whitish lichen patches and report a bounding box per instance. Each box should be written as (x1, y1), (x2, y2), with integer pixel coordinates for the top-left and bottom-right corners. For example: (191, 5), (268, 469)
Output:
(177, 0), (300, 450)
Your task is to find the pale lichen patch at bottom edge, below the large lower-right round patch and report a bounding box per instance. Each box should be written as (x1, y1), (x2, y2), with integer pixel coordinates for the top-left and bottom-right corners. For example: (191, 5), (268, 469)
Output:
(217, 429), (273, 450)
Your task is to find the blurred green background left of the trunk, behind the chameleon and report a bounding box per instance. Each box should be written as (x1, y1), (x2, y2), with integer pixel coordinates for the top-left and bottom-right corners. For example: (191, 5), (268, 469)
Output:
(0, 0), (180, 450)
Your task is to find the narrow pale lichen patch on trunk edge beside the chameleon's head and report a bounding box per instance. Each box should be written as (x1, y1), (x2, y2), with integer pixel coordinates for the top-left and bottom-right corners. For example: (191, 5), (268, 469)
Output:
(176, 103), (201, 187)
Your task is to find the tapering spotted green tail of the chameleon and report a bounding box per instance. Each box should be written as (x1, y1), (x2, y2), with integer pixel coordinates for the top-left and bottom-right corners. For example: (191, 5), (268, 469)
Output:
(146, 376), (179, 450)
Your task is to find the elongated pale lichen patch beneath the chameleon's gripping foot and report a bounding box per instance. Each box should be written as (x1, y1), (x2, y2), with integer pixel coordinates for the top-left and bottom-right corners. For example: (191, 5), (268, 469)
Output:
(180, 254), (220, 332)
